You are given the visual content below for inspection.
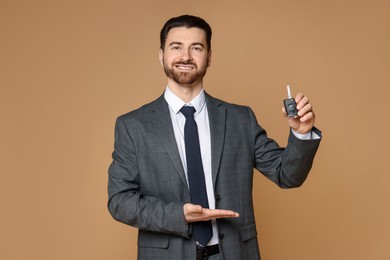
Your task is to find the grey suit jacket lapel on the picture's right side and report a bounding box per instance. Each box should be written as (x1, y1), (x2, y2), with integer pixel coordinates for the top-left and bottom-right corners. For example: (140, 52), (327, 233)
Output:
(206, 93), (226, 188)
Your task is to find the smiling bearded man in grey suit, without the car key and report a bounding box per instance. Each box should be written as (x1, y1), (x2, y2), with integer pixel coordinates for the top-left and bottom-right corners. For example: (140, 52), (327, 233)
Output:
(108, 15), (321, 260)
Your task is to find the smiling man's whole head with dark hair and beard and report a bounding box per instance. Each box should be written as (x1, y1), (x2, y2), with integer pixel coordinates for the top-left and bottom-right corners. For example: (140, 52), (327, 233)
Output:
(159, 15), (211, 87)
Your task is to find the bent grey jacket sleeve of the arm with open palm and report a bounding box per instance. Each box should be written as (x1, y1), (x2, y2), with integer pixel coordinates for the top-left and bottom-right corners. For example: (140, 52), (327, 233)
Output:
(108, 117), (188, 237)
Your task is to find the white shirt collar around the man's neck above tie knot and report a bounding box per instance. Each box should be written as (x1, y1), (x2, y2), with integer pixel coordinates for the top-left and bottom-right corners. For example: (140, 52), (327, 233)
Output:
(164, 87), (206, 114)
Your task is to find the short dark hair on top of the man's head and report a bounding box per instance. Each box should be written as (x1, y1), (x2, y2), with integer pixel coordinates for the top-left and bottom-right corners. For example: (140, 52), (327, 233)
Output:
(160, 15), (212, 51)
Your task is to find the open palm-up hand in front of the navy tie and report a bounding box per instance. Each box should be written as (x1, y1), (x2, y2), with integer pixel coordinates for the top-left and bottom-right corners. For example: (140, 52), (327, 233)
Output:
(183, 203), (240, 223)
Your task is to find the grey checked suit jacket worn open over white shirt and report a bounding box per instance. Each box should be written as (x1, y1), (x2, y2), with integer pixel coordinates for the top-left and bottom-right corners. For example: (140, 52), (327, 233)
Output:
(108, 94), (320, 260)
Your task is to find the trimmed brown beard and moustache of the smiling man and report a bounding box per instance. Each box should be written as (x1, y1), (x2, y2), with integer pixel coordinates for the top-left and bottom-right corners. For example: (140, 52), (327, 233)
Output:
(164, 62), (207, 85)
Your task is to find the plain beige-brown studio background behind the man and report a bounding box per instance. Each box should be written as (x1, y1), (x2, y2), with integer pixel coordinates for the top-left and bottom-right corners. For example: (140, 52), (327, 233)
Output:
(0, 0), (390, 260)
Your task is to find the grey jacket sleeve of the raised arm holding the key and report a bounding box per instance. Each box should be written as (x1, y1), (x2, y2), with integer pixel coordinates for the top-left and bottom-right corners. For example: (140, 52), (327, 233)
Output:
(249, 106), (322, 188)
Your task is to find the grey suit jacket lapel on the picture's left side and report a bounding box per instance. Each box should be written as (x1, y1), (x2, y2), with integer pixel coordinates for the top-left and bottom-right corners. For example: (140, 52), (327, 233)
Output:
(150, 96), (187, 187)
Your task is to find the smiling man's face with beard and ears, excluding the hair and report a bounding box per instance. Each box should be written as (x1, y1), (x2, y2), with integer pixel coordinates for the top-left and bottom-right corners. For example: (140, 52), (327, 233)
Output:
(159, 27), (211, 85)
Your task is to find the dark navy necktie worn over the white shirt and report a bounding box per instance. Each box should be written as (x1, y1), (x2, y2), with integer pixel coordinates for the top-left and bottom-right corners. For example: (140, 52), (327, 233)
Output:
(180, 106), (213, 246)
